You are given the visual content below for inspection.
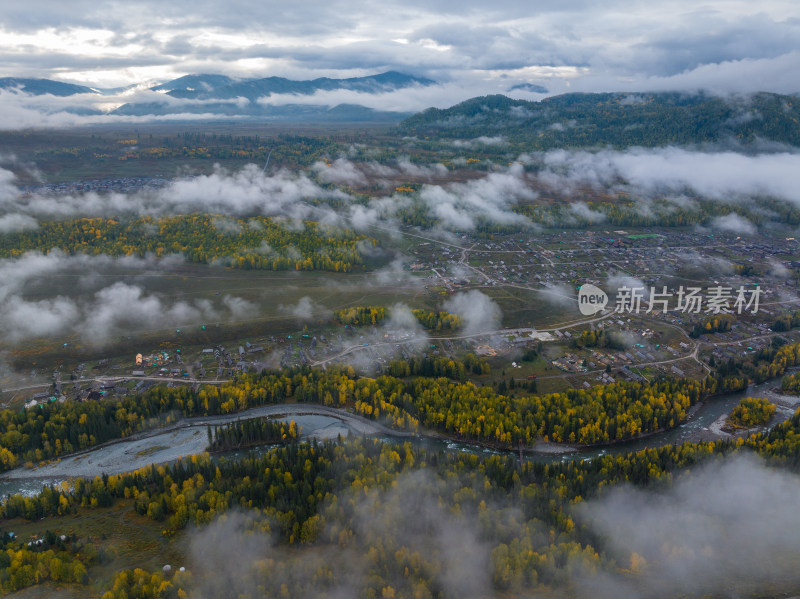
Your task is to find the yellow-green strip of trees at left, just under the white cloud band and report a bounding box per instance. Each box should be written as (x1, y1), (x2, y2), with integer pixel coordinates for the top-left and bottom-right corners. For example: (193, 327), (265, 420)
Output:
(0, 214), (378, 272)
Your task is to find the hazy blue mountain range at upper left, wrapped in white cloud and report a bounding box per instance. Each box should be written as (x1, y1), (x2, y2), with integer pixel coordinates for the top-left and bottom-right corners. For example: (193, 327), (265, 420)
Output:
(0, 71), (436, 123)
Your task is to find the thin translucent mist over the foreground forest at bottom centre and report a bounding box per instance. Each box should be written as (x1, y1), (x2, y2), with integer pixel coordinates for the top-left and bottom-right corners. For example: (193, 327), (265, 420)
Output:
(186, 470), (496, 599)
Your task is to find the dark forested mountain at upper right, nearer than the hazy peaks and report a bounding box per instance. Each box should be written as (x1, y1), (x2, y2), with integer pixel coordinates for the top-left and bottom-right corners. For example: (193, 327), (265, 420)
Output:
(397, 92), (800, 150)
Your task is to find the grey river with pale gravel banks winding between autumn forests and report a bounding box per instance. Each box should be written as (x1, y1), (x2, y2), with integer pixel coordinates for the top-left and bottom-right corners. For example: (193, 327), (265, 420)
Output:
(0, 381), (800, 497)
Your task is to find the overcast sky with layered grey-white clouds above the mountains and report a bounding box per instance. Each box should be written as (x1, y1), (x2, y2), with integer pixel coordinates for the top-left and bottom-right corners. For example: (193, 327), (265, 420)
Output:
(0, 0), (800, 103)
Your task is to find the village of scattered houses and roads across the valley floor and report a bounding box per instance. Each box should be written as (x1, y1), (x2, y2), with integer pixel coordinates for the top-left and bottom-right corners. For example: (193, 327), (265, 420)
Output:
(6, 220), (800, 406)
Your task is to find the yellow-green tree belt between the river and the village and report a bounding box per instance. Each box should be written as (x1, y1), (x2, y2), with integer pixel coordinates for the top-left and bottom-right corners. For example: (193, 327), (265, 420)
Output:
(0, 352), (768, 470)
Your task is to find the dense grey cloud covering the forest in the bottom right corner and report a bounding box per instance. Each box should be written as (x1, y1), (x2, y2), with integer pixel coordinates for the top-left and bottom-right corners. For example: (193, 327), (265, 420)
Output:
(576, 455), (800, 599)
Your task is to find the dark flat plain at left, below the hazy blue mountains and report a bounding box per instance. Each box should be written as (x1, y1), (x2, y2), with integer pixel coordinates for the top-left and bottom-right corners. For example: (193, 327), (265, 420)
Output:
(0, 122), (386, 184)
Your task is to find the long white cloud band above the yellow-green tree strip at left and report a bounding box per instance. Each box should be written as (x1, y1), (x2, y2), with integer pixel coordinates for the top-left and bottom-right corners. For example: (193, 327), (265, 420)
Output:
(0, 158), (537, 233)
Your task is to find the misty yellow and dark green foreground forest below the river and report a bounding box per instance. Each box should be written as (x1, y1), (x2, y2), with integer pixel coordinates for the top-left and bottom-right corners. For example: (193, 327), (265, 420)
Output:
(0, 413), (800, 599)
